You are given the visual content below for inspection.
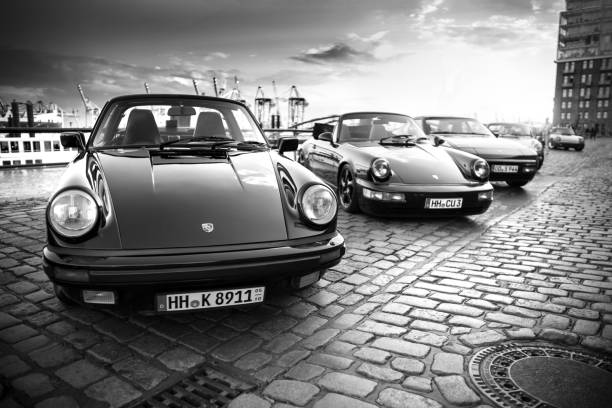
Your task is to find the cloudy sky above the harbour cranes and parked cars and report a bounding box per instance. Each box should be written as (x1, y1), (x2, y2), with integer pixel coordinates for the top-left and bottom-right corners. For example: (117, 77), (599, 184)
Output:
(0, 0), (565, 124)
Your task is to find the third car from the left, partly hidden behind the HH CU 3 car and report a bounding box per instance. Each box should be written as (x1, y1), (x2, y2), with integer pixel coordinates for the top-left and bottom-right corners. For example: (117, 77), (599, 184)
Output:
(416, 116), (538, 187)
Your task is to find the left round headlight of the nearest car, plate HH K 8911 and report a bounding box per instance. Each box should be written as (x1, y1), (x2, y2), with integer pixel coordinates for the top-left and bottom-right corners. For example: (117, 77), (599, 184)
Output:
(49, 190), (98, 238)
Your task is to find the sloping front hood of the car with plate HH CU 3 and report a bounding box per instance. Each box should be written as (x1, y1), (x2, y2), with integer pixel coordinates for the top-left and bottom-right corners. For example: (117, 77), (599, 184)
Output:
(352, 144), (466, 185)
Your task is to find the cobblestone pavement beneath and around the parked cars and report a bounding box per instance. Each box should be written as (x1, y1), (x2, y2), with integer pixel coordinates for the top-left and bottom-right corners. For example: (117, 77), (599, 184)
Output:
(0, 140), (612, 408)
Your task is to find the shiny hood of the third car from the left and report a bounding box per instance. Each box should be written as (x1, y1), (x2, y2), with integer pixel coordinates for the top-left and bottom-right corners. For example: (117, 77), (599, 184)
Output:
(445, 136), (535, 159)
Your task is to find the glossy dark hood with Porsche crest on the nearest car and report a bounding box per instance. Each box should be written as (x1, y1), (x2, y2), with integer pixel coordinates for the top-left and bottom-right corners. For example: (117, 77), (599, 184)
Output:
(97, 149), (287, 249)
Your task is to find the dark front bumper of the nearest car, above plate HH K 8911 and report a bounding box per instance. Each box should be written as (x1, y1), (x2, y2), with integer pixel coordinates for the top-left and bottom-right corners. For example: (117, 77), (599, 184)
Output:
(43, 232), (345, 309)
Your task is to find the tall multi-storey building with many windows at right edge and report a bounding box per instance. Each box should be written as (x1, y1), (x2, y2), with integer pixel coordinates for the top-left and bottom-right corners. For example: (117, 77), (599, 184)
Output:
(553, 0), (612, 136)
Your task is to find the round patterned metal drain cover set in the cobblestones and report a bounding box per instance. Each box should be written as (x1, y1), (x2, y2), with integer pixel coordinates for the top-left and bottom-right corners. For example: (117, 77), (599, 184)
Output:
(469, 343), (612, 408)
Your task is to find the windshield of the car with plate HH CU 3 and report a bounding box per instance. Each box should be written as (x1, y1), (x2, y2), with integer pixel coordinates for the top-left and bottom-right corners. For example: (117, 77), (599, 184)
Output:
(338, 113), (425, 142)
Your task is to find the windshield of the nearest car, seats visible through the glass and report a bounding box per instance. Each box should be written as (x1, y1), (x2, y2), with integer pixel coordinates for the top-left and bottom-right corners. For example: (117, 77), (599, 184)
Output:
(92, 97), (266, 148)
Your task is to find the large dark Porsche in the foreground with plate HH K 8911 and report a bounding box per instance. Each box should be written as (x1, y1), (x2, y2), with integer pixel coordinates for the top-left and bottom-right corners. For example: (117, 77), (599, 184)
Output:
(43, 95), (345, 312)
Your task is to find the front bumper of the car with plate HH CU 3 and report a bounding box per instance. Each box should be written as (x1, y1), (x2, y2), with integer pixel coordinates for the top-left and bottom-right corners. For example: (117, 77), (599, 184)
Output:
(357, 179), (493, 217)
